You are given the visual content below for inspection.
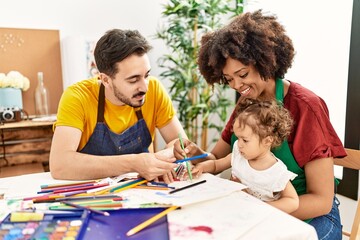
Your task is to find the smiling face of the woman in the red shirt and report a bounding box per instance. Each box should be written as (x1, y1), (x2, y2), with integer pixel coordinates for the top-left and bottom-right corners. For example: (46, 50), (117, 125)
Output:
(223, 57), (271, 99)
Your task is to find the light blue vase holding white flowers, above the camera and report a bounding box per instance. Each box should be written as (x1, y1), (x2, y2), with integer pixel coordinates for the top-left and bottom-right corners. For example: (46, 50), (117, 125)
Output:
(0, 88), (22, 109)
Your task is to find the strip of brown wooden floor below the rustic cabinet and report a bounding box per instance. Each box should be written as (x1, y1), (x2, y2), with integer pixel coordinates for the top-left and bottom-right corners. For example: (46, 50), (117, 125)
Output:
(0, 163), (45, 178)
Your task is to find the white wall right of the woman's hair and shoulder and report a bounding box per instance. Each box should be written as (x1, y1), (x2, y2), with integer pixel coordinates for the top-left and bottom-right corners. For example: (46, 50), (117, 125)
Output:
(246, 0), (352, 144)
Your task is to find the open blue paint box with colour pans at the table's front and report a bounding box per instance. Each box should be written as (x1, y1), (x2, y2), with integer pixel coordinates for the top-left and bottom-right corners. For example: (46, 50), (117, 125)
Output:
(0, 208), (169, 240)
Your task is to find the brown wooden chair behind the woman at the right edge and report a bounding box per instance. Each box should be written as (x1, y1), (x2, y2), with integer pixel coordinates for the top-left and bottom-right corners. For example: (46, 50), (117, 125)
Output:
(334, 148), (360, 240)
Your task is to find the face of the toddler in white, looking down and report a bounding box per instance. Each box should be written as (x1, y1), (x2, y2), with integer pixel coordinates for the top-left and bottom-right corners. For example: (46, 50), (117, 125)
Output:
(233, 120), (270, 160)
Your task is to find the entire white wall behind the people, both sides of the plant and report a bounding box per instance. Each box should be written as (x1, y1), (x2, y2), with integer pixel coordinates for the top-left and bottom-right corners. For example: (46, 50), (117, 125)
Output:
(0, 0), (352, 232)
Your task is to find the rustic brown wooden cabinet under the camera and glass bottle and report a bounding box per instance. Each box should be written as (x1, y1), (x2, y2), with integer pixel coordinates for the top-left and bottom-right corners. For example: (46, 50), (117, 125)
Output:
(0, 120), (53, 171)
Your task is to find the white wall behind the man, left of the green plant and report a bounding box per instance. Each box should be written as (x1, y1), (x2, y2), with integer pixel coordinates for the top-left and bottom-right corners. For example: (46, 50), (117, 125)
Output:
(0, 0), (165, 87)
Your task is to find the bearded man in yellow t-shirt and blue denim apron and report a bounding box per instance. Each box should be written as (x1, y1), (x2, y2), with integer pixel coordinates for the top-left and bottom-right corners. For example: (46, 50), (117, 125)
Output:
(50, 29), (186, 182)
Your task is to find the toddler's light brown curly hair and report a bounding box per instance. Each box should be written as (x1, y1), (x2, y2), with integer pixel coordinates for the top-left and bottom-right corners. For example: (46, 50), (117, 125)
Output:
(234, 98), (293, 148)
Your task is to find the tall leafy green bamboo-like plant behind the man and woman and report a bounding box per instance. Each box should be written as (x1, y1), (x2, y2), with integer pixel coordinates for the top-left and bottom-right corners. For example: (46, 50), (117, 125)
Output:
(156, 0), (243, 150)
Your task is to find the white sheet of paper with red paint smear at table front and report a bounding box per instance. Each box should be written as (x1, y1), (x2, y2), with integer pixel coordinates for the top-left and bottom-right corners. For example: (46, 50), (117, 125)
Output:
(168, 192), (273, 240)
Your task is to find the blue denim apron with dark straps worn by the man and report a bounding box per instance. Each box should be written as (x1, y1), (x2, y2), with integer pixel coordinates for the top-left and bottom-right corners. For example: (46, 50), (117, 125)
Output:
(80, 84), (152, 155)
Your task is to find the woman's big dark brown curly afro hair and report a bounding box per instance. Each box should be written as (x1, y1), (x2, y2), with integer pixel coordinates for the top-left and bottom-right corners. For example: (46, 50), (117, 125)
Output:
(197, 10), (295, 85)
